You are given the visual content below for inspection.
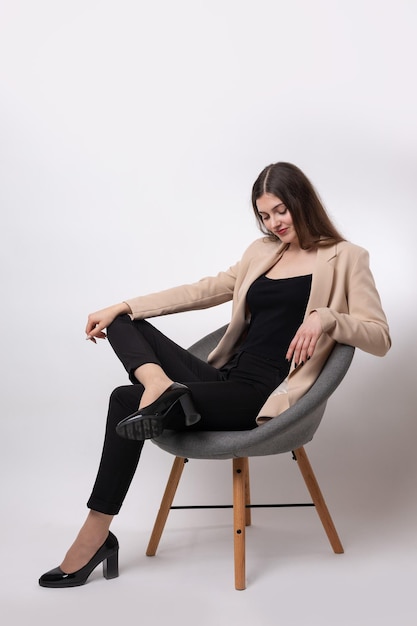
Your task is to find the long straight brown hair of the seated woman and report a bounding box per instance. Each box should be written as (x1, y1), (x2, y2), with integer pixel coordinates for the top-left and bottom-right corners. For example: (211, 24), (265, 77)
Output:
(252, 162), (344, 249)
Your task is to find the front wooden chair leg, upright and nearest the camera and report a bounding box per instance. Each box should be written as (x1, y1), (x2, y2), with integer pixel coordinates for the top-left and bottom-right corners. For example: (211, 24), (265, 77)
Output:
(233, 458), (248, 590)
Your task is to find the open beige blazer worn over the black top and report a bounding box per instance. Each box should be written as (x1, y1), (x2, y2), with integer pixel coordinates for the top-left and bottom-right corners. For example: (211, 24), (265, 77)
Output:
(126, 237), (391, 423)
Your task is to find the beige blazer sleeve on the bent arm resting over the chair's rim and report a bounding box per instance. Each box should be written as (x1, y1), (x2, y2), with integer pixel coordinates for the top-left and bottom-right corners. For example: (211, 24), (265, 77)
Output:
(316, 247), (391, 356)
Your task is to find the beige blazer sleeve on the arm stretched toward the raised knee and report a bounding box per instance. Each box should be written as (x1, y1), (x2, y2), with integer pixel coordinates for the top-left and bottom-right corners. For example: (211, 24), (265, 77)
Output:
(125, 263), (239, 319)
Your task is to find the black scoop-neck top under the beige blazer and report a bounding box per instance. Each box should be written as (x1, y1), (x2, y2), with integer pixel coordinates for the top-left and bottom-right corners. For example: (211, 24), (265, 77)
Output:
(240, 274), (312, 365)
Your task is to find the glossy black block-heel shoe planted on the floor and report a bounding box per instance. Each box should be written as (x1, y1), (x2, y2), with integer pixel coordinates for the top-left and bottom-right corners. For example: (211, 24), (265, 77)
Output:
(39, 532), (119, 588)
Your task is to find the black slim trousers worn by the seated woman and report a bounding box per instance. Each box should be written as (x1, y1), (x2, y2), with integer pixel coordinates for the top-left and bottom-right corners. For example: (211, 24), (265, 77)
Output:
(87, 315), (287, 515)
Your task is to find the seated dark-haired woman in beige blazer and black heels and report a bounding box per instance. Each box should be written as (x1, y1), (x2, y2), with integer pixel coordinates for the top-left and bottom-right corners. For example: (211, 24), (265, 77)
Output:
(39, 163), (391, 587)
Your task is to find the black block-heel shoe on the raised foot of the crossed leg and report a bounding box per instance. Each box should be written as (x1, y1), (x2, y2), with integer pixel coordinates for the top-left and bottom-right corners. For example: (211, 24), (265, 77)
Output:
(116, 383), (201, 441)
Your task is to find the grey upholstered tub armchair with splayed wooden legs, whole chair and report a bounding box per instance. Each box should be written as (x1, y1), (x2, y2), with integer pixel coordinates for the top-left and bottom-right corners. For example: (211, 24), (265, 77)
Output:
(146, 326), (354, 589)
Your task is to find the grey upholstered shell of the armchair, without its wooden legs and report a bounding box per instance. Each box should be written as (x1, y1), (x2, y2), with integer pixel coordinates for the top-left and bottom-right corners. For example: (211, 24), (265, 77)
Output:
(155, 326), (355, 459)
